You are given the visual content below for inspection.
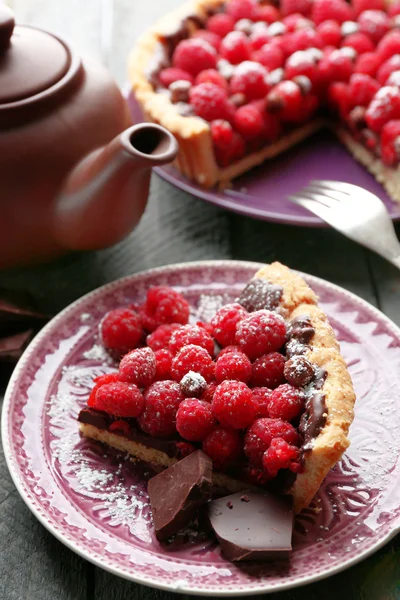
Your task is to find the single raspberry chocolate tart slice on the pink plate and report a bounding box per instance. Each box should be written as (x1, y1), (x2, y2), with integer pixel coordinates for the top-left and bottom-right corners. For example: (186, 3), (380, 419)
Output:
(79, 263), (355, 512)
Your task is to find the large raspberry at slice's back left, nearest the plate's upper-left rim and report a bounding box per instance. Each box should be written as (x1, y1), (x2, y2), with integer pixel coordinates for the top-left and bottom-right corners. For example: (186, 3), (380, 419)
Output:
(100, 308), (143, 358)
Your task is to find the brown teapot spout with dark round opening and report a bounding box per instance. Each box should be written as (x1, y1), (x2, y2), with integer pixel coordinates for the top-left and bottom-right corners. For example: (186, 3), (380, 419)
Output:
(53, 123), (178, 250)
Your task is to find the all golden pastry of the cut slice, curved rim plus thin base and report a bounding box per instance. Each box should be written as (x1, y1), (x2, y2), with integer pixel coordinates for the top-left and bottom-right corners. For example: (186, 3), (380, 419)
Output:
(80, 262), (355, 513)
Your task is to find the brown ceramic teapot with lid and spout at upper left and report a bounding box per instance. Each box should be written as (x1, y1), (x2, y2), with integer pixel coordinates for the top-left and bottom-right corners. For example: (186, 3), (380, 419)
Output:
(0, 5), (177, 267)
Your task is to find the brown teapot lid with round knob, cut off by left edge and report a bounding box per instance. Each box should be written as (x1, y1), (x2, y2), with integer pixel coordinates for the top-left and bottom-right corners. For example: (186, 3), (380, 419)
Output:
(0, 4), (71, 105)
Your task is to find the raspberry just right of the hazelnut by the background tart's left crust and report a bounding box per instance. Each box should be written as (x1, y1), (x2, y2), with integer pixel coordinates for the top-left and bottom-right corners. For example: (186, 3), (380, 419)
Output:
(189, 83), (231, 121)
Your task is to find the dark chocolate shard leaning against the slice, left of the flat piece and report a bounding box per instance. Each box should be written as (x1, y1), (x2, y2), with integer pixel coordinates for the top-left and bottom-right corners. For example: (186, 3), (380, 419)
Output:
(147, 450), (212, 541)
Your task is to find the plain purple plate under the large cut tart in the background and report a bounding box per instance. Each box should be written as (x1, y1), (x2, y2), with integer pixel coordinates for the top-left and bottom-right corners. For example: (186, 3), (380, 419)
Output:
(125, 90), (400, 227)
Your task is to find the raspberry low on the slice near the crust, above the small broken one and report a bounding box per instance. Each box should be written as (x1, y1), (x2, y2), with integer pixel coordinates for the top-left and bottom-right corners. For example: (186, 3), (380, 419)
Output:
(244, 418), (299, 467)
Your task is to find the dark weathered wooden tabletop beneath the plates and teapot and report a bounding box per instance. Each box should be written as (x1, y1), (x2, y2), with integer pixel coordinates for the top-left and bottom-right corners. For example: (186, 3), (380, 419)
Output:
(0, 0), (400, 600)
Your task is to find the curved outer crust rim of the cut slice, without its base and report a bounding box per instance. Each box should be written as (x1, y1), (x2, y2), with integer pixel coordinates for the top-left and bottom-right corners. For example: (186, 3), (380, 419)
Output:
(256, 263), (356, 513)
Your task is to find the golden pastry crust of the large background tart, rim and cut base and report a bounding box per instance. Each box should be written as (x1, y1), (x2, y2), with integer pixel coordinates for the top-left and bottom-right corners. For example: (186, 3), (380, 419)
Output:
(128, 0), (324, 187)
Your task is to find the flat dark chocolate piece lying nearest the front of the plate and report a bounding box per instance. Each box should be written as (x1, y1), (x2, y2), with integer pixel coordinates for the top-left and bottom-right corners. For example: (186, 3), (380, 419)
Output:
(208, 491), (293, 561)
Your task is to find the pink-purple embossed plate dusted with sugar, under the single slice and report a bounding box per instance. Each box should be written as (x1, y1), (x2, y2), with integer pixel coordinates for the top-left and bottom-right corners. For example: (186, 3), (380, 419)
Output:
(2, 261), (400, 596)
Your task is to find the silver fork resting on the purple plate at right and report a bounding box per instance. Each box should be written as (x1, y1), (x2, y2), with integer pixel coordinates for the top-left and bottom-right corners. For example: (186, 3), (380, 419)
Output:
(289, 181), (400, 269)
